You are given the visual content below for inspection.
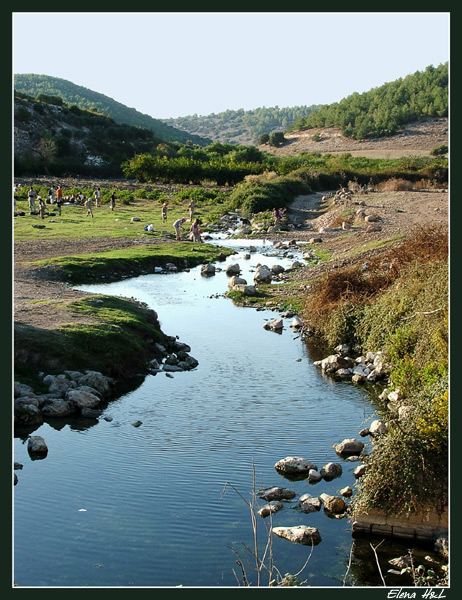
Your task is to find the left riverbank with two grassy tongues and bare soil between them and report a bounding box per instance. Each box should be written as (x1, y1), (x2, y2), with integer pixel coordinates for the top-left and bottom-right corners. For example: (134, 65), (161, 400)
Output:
(14, 239), (233, 384)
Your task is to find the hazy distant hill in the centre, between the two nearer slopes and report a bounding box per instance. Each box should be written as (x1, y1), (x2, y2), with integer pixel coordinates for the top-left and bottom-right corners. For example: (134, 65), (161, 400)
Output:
(162, 105), (321, 146)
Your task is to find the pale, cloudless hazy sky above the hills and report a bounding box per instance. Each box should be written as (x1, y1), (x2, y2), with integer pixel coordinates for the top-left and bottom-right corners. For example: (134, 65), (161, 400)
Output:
(12, 12), (450, 118)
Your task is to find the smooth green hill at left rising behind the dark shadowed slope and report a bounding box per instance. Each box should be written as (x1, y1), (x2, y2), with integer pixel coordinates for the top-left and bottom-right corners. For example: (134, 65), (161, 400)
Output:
(14, 74), (213, 146)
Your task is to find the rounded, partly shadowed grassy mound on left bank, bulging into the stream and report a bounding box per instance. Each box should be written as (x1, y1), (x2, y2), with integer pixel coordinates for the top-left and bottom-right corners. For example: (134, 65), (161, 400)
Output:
(15, 295), (170, 378)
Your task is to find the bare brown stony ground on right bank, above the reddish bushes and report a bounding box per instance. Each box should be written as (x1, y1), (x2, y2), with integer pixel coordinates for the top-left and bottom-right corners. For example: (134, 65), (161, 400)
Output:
(256, 189), (449, 299)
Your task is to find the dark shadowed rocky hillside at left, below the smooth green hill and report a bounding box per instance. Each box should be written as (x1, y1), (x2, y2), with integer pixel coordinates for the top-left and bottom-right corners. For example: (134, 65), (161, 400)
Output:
(14, 93), (179, 178)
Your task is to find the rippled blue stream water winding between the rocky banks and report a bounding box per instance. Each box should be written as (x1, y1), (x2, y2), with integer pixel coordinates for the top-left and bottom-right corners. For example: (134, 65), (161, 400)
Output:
(14, 241), (416, 587)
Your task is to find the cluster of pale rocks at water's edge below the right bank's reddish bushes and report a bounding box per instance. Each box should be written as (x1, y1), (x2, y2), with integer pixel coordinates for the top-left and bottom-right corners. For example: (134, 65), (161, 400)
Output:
(313, 344), (390, 384)
